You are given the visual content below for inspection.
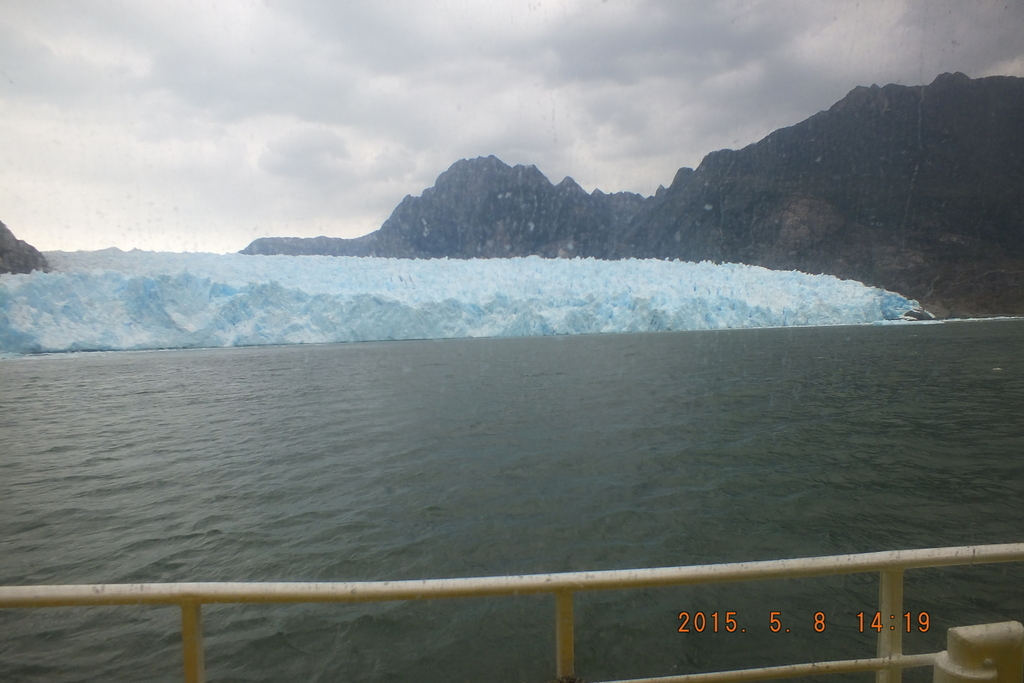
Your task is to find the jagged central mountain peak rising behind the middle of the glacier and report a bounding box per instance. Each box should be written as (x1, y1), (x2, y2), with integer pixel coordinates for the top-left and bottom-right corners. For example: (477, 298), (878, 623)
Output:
(243, 157), (646, 258)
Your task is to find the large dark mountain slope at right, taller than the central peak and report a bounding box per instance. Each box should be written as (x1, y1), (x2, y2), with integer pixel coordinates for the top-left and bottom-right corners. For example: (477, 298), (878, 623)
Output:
(629, 74), (1024, 314)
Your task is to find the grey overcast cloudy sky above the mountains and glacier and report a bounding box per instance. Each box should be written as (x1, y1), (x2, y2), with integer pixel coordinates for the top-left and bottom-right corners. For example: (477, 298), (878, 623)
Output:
(0, 0), (1024, 252)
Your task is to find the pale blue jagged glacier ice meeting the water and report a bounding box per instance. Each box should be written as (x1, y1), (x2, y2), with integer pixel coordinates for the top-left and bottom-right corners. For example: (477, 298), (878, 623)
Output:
(0, 249), (919, 357)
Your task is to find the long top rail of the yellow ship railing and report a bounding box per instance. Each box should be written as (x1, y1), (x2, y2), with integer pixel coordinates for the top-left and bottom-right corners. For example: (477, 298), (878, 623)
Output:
(0, 543), (1024, 607)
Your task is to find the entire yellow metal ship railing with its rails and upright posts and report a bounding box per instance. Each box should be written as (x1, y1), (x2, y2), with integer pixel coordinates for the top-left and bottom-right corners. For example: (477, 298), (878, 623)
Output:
(0, 543), (1024, 683)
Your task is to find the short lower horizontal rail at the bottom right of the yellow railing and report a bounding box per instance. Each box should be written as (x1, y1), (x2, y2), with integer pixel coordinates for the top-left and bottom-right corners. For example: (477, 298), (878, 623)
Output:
(608, 652), (939, 683)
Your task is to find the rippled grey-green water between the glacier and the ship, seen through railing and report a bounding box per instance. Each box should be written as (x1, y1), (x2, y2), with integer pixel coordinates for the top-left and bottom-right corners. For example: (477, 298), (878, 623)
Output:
(0, 321), (1024, 683)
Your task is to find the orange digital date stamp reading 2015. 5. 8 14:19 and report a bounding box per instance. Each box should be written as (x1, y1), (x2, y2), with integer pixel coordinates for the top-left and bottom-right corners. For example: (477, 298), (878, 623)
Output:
(679, 611), (932, 633)
